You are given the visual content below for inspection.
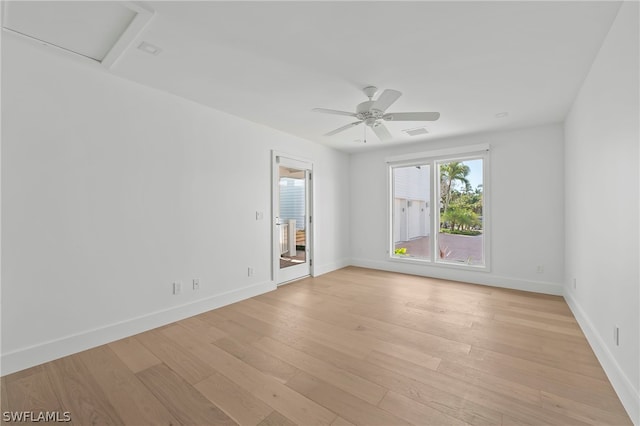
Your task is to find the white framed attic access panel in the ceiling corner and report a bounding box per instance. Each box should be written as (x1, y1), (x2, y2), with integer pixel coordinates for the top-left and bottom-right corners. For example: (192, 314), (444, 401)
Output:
(2, 1), (153, 67)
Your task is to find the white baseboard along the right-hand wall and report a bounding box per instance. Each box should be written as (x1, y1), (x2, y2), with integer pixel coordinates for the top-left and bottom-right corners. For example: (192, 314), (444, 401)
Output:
(564, 291), (640, 426)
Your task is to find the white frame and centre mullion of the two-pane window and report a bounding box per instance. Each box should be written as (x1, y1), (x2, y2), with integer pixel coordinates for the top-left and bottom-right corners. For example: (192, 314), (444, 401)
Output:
(385, 144), (491, 272)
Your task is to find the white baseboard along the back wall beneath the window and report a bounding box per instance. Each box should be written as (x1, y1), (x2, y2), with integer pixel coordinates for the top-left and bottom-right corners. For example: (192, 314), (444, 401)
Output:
(351, 259), (563, 296)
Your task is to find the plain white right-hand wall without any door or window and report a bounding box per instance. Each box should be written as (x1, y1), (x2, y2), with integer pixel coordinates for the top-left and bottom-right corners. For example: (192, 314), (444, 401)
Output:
(565, 2), (640, 425)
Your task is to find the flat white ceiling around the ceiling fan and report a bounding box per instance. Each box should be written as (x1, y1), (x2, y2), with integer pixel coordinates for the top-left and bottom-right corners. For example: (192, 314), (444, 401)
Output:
(8, 1), (620, 151)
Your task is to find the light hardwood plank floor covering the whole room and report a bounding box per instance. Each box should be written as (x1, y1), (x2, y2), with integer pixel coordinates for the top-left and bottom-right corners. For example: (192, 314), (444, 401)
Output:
(1, 267), (631, 426)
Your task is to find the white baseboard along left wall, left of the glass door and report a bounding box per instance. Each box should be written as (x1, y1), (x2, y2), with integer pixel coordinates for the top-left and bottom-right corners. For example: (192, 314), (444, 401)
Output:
(0, 281), (276, 376)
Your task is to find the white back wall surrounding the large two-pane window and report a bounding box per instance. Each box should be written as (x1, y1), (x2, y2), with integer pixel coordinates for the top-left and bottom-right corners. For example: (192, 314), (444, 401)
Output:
(350, 124), (564, 294)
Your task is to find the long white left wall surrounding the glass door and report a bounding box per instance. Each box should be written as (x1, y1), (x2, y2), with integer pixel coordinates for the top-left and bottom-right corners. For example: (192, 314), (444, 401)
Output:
(2, 34), (350, 374)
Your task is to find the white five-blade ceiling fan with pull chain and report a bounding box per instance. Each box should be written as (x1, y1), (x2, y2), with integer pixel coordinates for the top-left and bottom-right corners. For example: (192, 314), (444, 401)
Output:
(312, 86), (440, 142)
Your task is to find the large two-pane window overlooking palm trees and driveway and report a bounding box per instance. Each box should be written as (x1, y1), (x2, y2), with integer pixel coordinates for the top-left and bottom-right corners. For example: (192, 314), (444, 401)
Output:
(388, 147), (488, 269)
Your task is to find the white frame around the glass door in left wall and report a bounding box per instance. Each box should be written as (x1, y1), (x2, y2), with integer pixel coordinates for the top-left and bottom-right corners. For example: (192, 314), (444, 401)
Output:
(271, 150), (316, 286)
